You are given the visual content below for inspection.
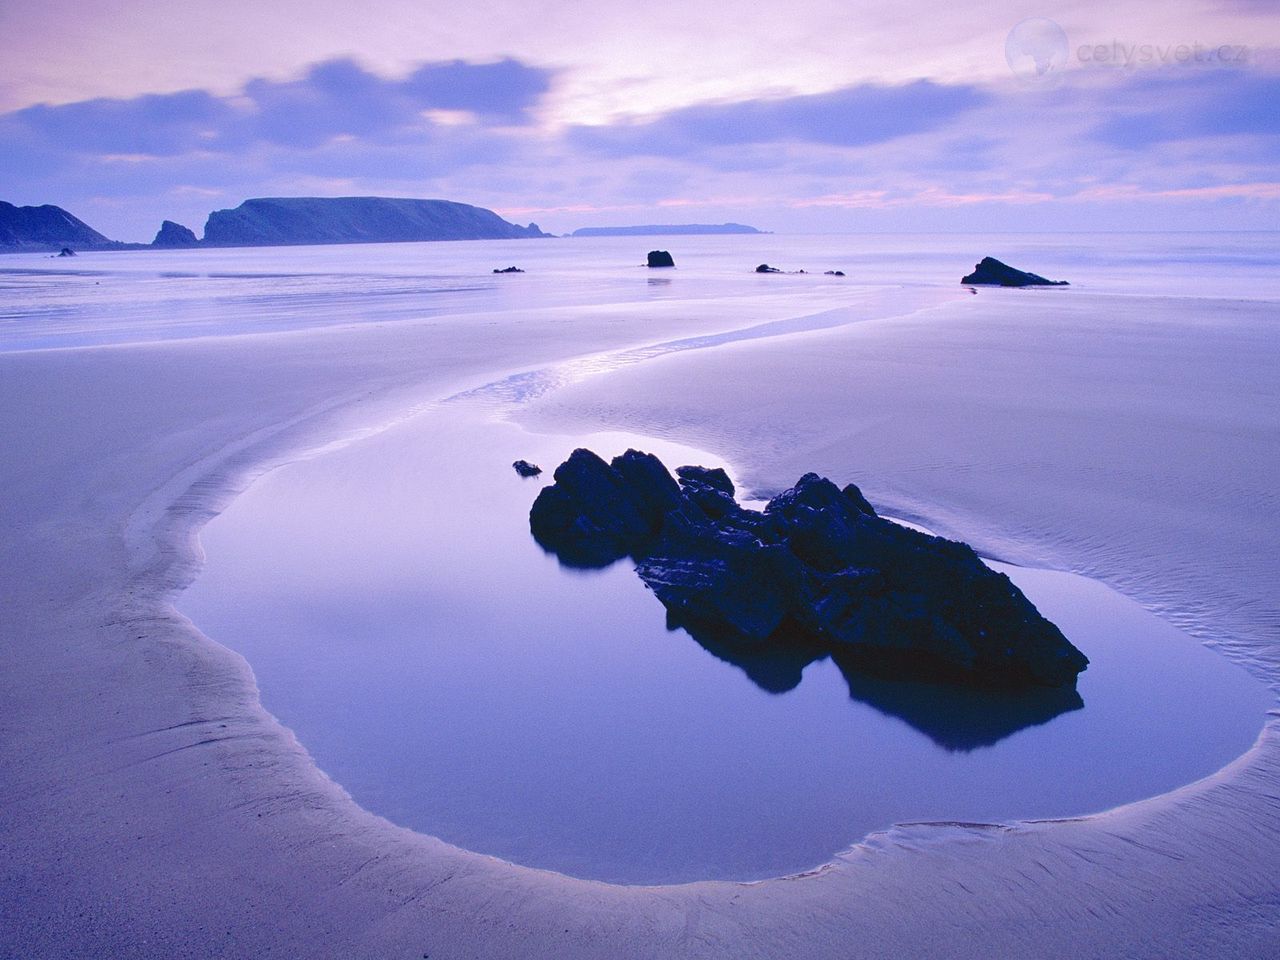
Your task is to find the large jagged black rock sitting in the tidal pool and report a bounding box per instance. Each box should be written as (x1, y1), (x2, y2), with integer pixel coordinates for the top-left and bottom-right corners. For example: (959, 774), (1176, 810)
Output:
(529, 449), (1088, 687)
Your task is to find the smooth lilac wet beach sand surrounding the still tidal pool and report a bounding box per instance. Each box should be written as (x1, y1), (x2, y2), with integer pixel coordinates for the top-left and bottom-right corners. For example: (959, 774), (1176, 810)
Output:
(0, 277), (1280, 957)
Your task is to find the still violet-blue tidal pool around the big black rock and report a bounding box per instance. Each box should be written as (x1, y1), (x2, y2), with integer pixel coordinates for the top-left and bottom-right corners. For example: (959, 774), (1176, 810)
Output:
(179, 403), (1270, 883)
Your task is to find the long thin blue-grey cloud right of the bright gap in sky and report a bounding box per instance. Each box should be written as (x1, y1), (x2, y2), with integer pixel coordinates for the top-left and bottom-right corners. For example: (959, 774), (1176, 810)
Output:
(568, 81), (988, 156)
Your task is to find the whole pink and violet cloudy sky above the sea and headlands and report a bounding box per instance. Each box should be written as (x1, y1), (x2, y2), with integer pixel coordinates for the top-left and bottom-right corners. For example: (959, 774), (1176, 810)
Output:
(0, 0), (1280, 241)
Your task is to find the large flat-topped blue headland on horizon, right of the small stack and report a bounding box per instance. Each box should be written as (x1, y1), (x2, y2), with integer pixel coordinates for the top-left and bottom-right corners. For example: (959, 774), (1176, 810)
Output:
(204, 197), (547, 247)
